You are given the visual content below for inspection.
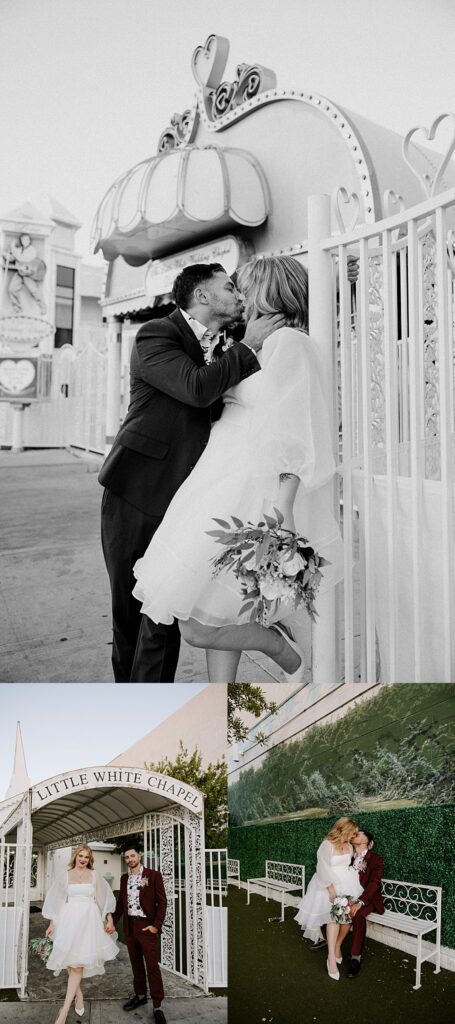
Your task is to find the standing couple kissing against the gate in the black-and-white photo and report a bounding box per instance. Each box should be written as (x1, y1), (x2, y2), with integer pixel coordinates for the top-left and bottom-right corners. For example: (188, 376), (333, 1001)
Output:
(99, 256), (342, 683)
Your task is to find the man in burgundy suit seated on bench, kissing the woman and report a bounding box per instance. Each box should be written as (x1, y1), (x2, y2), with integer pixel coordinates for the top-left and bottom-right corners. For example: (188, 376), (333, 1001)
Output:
(309, 831), (384, 978)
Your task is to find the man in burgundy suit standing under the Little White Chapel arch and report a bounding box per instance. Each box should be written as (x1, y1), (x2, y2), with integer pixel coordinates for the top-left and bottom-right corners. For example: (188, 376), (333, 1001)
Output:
(106, 843), (167, 1024)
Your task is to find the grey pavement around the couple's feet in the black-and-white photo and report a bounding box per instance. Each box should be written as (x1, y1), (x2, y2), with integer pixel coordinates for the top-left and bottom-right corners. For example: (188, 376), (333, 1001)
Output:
(0, 450), (297, 683)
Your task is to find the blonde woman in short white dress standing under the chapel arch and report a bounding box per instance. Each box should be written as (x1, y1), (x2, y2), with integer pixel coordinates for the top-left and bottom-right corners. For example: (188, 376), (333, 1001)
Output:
(41, 845), (119, 1024)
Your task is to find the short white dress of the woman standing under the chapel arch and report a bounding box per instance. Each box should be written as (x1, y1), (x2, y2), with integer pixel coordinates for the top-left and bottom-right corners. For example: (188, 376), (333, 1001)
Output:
(41, 871), (119, 978)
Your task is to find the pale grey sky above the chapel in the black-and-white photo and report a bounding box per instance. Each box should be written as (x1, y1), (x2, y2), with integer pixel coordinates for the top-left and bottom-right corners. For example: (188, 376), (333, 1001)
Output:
(0, 0), (455, 254)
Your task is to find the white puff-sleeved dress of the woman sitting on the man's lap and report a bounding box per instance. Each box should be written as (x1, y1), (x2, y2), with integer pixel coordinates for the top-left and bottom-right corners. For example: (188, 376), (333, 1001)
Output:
(294, 839), (363, 942)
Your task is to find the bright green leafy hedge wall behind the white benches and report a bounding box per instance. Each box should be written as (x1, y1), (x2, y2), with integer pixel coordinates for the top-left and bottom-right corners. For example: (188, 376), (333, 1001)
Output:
(229, 804), (455, 948)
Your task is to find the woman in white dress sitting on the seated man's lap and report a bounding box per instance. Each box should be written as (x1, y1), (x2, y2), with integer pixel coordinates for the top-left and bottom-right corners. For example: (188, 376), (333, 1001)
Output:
(295, 818), (363, 981)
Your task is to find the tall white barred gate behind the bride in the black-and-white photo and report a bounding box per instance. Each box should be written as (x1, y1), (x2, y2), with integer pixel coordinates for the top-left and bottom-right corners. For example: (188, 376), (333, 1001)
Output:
(309, 189), (455, 683)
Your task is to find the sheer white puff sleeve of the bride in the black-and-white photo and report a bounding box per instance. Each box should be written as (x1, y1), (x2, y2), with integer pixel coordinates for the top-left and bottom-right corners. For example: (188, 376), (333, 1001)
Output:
(246, 328), (335, 499)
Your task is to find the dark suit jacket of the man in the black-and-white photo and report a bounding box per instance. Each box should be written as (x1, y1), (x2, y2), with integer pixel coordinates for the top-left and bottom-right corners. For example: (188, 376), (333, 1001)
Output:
(98, 301), (259, 512)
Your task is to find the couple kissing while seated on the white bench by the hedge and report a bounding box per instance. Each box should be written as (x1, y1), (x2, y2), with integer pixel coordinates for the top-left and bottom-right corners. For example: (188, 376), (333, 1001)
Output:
(295, 818), (384, 981)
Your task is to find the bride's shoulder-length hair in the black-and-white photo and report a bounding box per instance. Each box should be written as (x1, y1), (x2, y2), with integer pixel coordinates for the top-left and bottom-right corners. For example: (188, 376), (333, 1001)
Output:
(237, 256), (308, 331)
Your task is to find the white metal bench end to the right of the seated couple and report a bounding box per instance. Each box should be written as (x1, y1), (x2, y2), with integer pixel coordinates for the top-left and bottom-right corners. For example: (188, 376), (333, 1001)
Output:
(367, 879), (443, 988)
